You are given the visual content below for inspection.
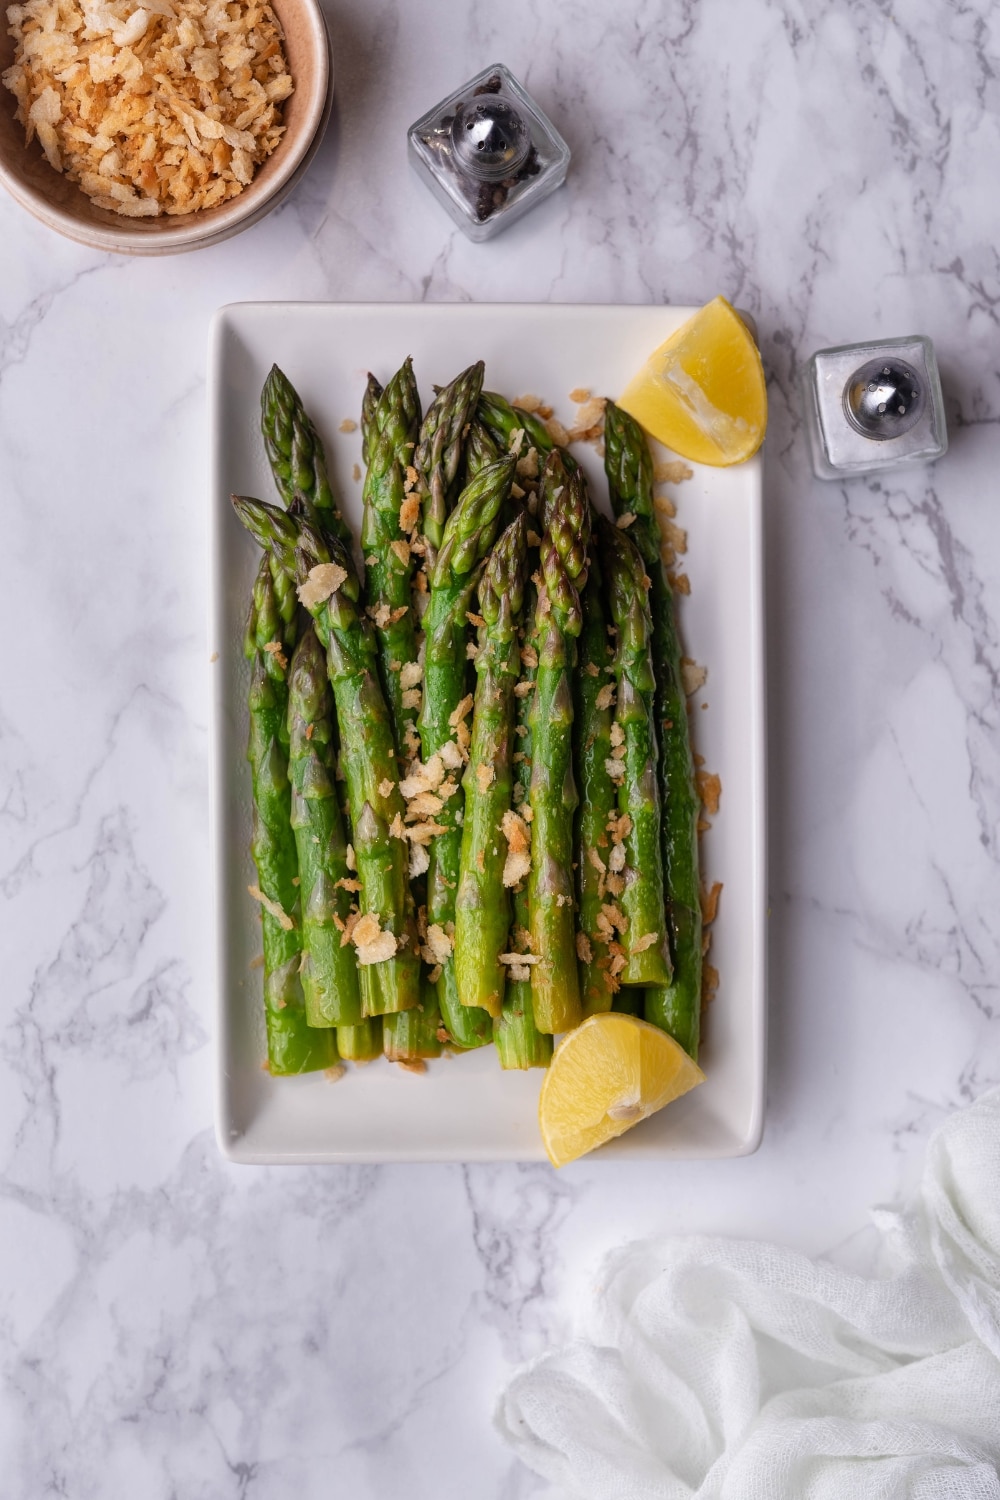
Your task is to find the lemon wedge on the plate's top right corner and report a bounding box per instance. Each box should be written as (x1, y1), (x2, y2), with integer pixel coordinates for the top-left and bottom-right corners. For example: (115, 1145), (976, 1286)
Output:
(618, 297), (768, 468)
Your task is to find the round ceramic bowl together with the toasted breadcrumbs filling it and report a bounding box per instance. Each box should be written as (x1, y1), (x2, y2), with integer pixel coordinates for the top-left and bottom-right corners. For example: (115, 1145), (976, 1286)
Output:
(0, 0), (333, 255)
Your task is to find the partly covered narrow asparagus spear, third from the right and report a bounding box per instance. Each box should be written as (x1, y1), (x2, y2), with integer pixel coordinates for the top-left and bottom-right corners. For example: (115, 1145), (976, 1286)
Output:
(573, 546), (618, 1016)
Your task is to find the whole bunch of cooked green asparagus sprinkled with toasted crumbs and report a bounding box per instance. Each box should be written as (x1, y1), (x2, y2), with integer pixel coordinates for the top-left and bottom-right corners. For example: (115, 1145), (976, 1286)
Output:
(234, 359), (702, 1074)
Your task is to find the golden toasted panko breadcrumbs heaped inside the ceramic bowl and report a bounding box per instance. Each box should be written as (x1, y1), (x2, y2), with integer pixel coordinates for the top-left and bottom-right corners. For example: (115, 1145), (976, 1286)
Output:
(1, 0), (294, 219)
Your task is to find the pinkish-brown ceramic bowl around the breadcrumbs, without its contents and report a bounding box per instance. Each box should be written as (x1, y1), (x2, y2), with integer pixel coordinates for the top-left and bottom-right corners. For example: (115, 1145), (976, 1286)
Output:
(0, 0), (333, 255)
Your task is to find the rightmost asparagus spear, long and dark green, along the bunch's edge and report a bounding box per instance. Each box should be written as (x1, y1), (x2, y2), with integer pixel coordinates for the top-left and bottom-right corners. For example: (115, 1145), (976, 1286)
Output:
(604, 401), (702, 1058)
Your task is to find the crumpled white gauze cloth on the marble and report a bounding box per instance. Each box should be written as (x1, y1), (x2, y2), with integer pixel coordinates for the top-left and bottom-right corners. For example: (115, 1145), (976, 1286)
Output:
(496, 1089), (1000, 1500)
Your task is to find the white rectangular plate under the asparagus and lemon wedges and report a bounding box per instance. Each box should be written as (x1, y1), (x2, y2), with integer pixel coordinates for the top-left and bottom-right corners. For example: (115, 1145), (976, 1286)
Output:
(210, 303), (765, 1163)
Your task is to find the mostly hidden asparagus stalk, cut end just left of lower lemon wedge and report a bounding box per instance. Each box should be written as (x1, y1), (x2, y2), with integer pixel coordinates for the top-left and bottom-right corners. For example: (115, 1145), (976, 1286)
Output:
(493, 570), (552, 1068)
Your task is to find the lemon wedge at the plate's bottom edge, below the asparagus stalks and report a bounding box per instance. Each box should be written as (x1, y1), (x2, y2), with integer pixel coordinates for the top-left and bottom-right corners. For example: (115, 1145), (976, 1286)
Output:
(538, 1011), (705, 1167)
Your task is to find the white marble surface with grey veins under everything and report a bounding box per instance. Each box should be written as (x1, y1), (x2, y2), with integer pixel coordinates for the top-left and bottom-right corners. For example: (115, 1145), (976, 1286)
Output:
(0, 0), (1000, 1500)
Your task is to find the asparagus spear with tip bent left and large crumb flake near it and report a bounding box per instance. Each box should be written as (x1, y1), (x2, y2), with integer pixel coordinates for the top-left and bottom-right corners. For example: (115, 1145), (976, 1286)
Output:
(232, 495), (420, 1014)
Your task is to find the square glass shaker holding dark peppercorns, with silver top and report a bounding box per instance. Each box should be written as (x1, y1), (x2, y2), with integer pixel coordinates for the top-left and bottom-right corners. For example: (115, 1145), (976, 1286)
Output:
(406, 63), (570, 240)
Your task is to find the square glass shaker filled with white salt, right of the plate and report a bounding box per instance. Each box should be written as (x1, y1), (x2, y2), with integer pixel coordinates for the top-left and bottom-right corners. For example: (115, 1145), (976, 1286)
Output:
(802, 335), (948, 479)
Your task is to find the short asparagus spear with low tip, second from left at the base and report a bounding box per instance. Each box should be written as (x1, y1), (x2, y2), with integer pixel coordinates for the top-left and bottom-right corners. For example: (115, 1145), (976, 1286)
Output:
(288, 627), (361, 1026)
